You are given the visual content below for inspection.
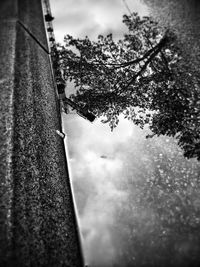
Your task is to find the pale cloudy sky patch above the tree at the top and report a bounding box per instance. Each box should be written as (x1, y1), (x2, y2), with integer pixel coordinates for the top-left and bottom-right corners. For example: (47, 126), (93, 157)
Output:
(51, 0), (148, 42)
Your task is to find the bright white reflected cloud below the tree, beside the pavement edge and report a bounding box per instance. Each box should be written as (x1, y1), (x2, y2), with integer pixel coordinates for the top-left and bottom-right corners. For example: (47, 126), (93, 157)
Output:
(63, 115), (133, 266)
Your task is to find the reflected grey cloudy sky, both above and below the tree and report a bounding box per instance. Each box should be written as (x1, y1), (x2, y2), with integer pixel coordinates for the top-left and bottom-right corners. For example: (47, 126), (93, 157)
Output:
(50, 0), (200, 267)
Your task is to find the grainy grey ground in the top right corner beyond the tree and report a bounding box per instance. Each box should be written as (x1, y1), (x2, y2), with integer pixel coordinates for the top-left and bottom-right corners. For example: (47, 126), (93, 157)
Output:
(143, 0), (200, 73)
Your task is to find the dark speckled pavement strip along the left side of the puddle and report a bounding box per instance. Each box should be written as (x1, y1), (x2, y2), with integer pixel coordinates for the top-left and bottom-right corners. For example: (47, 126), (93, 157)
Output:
(0, 0), (83, 267)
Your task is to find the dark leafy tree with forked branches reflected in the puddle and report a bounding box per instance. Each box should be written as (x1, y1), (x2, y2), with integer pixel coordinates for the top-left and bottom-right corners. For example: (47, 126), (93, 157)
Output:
(58, 13), (200, 160)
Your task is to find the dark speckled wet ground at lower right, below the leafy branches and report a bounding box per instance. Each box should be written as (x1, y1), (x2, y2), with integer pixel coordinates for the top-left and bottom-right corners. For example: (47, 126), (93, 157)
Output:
(113, 138), (200, 267)
